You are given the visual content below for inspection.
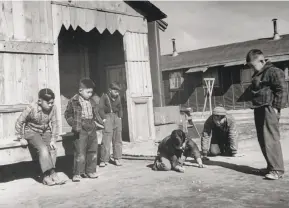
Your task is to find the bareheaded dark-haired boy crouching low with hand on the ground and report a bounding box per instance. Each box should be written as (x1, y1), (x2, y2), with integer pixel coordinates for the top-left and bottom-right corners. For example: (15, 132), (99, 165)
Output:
(153, 129), (205, 173)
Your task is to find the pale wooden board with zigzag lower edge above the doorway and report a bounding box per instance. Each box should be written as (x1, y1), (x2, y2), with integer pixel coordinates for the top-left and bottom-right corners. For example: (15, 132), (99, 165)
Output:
(52, 2), (147, 42)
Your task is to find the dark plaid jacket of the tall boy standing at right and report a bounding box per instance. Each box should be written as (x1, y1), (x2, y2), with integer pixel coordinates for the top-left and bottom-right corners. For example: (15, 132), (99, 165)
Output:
(250, 62), (287, 110)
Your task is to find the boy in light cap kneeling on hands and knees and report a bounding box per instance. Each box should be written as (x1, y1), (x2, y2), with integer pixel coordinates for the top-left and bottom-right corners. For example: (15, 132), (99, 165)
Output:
(201, 107), (238, 158)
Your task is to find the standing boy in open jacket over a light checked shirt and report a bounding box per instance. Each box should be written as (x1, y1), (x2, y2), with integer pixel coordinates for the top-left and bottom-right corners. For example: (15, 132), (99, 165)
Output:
(65, 79), (103, 182)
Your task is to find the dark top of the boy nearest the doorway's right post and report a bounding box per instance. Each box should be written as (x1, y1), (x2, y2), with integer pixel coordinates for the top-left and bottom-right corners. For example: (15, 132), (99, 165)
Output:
(99, 93), (123, 119)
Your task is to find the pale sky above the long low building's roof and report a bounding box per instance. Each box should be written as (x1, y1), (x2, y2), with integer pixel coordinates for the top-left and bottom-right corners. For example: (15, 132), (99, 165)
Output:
(152, 1), (289, 55)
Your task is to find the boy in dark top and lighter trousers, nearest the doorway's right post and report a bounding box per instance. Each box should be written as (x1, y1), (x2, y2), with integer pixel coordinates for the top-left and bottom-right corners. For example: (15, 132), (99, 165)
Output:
(99, 82), (123, 167)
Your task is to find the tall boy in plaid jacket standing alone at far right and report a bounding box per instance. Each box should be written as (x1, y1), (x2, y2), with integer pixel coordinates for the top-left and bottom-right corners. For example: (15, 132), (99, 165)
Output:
(246, 49), (287, 180)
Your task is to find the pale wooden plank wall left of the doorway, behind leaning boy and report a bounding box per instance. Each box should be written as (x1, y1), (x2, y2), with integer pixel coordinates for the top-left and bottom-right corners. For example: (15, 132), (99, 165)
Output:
(0, 1), (58, 140)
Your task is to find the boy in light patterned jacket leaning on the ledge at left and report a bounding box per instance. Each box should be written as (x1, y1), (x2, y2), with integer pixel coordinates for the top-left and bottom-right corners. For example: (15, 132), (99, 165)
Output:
(15, 88), (65, 186)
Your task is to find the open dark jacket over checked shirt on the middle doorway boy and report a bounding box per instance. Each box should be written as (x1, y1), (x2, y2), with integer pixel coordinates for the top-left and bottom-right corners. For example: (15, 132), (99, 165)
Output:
(64, 94), (103, 132)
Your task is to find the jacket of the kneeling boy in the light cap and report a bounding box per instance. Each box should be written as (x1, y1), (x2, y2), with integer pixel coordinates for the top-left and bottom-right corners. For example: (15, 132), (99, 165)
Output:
(201, 114), (238, 154)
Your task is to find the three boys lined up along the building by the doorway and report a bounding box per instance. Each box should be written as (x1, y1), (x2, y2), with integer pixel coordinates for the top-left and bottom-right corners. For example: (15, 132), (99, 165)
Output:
(15, 79), (123, 186)
